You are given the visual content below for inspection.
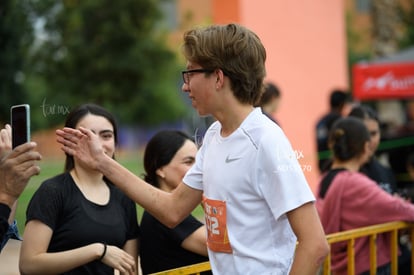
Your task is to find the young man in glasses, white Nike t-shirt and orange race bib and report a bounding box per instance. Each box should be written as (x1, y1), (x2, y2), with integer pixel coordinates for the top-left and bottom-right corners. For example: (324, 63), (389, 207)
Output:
(57, 24), (329, 275)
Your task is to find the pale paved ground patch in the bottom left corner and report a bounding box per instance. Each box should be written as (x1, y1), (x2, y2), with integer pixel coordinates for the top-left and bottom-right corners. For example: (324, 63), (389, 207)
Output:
(0, 240), (21, 275)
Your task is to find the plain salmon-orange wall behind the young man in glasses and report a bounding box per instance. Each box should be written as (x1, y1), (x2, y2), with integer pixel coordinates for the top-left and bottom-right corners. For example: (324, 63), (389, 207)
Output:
(212, 0), (348, 190)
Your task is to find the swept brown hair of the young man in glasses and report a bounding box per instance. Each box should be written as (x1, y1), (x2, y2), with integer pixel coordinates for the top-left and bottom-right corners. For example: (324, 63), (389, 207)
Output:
(183, 24), (266, 105)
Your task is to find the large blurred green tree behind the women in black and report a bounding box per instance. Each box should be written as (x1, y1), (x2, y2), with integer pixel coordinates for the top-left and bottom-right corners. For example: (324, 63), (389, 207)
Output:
(28, 0), (186, 129)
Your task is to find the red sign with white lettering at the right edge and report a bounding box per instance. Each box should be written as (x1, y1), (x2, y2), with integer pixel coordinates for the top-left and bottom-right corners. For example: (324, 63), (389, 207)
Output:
(352, 62), (414, 100)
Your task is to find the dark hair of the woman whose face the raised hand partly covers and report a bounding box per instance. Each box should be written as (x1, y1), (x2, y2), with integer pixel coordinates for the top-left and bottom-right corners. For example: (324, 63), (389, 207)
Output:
(65, 103), (118, 172)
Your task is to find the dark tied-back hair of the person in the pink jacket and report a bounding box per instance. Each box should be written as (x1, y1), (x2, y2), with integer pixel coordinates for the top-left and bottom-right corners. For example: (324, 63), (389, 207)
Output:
(329, 117), (370, 161)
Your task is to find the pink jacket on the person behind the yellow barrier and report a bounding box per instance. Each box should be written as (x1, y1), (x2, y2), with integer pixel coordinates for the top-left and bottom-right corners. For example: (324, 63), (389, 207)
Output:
(316, 171), (414, 274)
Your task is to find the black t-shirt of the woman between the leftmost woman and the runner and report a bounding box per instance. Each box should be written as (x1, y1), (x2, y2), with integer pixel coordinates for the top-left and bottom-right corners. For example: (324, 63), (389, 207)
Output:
(140, 211), (208, 274)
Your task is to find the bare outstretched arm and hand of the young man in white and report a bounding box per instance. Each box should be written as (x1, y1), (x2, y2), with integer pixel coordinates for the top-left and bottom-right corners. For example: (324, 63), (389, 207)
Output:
(56, 127), (202, 227)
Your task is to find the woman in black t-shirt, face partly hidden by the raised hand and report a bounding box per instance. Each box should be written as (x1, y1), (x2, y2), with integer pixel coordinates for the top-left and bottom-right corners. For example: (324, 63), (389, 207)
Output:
(19, 104), (139, 275)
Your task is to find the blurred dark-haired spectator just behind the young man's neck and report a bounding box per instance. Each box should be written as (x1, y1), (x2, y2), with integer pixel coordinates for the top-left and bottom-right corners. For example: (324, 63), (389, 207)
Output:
(256, 82), (281, 125)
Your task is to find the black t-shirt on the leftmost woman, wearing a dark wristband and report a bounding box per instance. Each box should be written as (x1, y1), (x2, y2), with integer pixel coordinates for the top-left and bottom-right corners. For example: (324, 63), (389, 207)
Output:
(26, 173), (140, 275)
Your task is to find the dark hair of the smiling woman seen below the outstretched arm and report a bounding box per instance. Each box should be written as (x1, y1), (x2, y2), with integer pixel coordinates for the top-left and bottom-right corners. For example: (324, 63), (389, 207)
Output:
(144, 130), (192, 188)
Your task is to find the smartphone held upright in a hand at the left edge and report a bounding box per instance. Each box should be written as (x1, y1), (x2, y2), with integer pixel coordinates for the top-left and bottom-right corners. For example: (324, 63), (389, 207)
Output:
(10, 104), (30, 149)
